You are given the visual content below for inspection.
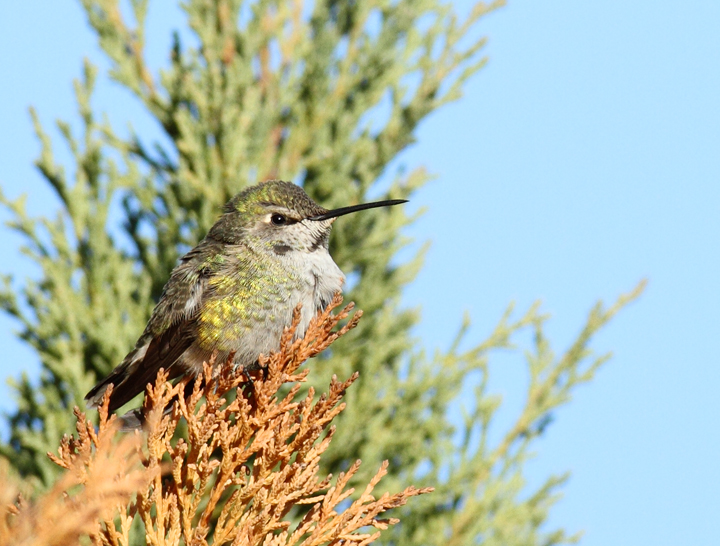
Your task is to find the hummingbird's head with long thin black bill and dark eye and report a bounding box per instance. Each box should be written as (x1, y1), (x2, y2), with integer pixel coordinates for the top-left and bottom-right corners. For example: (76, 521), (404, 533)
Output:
(208, 180), (406, 255)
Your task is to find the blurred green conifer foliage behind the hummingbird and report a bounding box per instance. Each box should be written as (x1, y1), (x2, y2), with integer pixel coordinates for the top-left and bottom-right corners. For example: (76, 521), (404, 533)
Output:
(0, 0), (639, 545)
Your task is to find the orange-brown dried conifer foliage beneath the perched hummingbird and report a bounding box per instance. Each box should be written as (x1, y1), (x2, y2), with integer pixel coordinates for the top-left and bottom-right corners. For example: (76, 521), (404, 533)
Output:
(0, 295), (431, 546)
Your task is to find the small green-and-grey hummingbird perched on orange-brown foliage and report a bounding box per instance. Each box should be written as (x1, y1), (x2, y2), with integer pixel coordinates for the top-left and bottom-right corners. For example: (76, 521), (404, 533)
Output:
(85, 180), (406, 418)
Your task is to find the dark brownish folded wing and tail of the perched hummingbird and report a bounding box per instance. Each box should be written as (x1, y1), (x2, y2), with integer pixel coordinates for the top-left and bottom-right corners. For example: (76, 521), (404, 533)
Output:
(85, 239), (220, 411)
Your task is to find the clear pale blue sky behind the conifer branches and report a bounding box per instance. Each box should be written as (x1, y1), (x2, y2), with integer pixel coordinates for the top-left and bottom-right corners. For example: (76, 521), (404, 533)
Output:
(0, 0), (720, 546)
